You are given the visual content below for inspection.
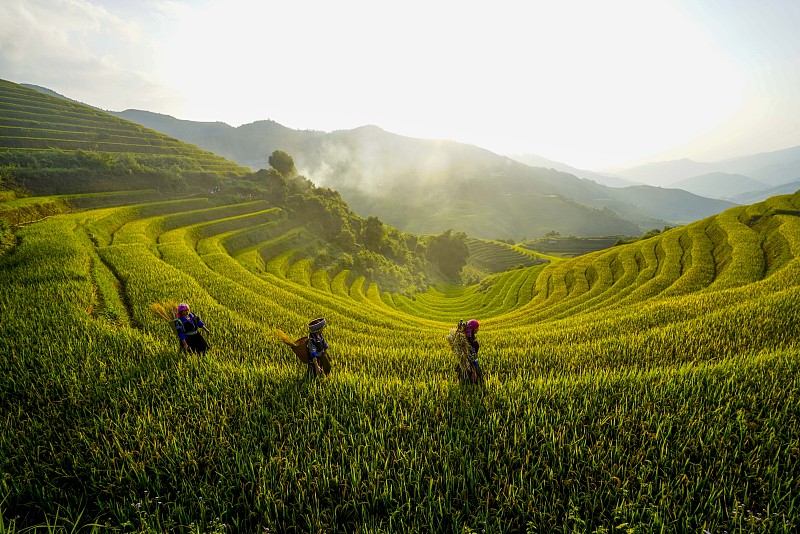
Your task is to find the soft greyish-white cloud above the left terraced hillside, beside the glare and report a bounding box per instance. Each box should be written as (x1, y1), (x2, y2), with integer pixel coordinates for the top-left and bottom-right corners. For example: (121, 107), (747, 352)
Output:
(0, 0), (181, 109)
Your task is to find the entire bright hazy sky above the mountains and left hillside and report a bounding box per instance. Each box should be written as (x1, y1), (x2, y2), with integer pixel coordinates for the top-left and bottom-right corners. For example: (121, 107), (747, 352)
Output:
(0, 0), (800, 169)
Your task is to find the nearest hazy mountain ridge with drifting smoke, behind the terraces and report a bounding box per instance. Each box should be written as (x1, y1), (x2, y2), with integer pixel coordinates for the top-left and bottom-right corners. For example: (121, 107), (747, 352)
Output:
(83, 110), (733, 239)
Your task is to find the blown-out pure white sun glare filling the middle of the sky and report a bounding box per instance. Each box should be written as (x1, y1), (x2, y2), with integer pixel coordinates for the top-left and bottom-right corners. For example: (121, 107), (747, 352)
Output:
(159, 0), (744, 168)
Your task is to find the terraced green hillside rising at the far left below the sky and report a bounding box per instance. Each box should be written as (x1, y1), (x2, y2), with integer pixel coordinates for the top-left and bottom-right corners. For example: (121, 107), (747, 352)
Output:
(0, 80), (250, 194)
